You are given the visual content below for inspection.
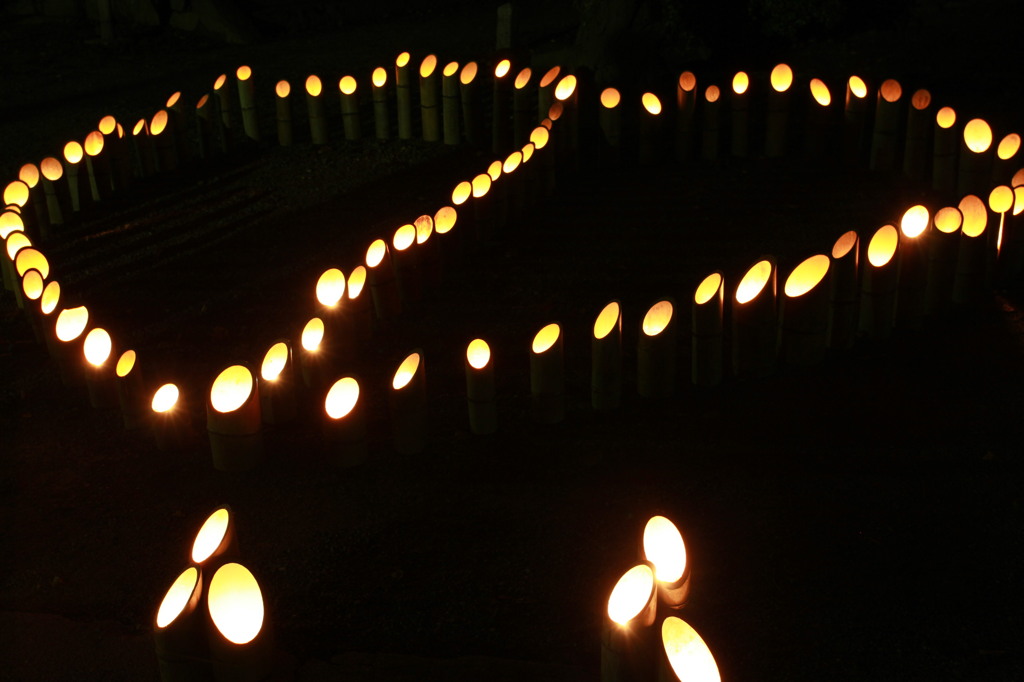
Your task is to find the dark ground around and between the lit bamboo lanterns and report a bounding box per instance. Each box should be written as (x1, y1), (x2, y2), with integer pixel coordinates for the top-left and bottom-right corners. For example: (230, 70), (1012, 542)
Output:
(0, 5), (1024, 680)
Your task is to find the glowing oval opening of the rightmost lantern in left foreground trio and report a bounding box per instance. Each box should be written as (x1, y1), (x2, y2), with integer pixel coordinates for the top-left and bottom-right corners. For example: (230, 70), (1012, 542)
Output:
(207, 563), (263, 644)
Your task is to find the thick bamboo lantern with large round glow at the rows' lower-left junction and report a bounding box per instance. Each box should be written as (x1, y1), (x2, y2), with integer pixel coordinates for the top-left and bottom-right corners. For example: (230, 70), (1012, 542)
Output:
(206, 365), (263, 471)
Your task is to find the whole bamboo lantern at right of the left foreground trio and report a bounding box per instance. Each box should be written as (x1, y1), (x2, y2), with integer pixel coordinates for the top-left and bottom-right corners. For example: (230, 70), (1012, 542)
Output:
(207, 562), (269, 682)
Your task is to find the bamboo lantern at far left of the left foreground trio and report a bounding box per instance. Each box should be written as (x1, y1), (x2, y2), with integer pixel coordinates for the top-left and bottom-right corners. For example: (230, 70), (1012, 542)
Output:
(153, 566), (212, 682)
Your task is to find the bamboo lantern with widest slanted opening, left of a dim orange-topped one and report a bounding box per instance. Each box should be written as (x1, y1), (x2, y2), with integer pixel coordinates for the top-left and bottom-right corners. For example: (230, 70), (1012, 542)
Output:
(779, 254), (831, 366)
